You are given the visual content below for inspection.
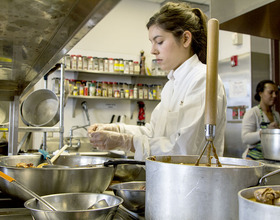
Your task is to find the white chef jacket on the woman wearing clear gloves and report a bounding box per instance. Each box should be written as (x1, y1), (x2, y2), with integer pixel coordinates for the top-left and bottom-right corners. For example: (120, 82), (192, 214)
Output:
(119, 54), (226, 160)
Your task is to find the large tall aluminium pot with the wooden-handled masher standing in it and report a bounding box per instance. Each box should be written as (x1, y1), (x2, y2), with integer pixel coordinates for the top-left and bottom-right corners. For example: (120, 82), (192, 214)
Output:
(145, 156), (264, 220)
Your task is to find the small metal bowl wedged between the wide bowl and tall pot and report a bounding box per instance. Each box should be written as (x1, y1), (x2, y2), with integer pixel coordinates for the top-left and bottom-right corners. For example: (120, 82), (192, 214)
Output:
(110, 181), (146, 213)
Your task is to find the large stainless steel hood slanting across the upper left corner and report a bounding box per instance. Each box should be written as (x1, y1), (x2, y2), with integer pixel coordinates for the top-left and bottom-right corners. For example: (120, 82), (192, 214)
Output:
(0, 0), (120, 101)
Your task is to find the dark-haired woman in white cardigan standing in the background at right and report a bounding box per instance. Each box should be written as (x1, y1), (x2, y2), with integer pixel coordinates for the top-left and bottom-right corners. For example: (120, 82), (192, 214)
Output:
(242, 80), (280, 160)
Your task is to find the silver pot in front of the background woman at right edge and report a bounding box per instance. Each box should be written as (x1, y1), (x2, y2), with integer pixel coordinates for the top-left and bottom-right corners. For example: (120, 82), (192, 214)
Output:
(261, 129), (280, 161)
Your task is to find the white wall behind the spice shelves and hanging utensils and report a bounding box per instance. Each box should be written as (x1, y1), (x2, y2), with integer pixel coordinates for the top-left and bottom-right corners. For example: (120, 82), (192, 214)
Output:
(33, 0), (270, 148)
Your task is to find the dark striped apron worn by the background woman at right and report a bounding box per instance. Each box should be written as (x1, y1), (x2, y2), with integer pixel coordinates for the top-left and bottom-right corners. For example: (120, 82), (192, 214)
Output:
(246, 105), (279, 160)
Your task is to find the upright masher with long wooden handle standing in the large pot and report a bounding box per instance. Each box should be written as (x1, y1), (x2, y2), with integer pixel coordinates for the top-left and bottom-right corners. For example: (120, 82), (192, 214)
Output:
(195, 18), (221, 166)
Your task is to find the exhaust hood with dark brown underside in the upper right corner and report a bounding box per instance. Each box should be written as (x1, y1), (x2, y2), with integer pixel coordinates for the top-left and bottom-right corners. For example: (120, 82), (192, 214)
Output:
(210, 0), (280, 40)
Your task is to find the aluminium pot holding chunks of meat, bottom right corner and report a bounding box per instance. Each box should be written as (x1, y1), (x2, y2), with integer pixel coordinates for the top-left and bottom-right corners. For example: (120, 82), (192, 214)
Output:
(238, 185), (280, 220)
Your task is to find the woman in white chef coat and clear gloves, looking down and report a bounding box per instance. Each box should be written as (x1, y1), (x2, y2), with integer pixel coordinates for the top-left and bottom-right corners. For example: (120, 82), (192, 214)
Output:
(88, 2), (226, 160)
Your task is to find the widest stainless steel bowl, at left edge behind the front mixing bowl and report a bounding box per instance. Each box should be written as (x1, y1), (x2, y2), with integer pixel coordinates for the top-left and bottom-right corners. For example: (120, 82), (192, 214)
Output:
(0, 155), (115, 201)
